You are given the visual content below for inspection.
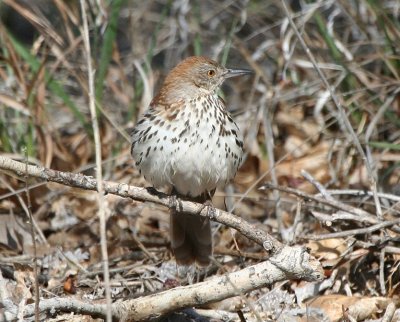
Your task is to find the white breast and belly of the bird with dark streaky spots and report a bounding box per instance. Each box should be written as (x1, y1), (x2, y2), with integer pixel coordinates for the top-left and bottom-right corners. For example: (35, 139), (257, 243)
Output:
(132, 94), (243, 197)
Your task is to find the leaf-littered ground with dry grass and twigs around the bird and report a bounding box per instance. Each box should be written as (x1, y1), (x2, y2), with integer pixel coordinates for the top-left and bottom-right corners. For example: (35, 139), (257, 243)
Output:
(0, 0), (400, 321)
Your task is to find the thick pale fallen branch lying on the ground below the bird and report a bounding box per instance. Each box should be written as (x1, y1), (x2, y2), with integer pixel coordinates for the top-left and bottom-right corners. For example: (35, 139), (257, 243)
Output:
(21, 247), (322, 321)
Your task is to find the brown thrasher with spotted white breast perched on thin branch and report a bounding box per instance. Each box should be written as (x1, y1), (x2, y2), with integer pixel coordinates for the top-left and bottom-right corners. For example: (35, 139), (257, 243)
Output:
(131, 56), (252, 267)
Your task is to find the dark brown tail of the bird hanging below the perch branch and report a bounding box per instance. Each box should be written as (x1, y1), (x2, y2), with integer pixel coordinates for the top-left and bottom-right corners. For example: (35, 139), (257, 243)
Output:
(170, 190), (212, 266)
